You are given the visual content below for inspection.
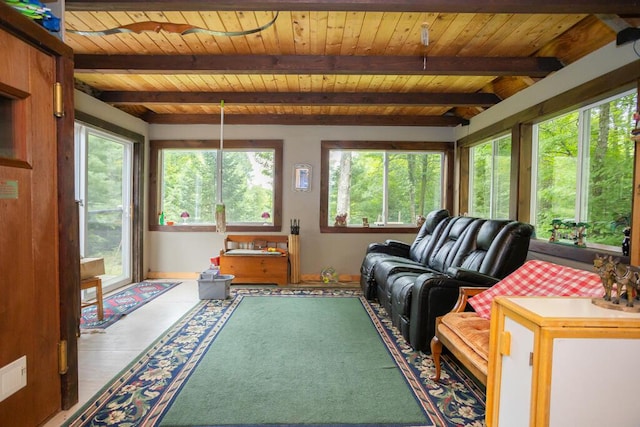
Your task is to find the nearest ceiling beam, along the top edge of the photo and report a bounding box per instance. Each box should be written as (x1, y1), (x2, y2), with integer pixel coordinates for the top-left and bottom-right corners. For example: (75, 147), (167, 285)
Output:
(65, 0), (640, 14)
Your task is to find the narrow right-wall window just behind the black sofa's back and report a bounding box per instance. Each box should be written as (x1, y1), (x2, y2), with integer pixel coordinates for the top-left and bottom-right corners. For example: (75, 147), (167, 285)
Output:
(469, 135), (511, 219)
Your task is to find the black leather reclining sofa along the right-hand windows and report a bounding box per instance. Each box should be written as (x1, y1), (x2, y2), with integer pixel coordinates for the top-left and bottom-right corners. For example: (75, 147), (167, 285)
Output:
(360, 210), (533, 352)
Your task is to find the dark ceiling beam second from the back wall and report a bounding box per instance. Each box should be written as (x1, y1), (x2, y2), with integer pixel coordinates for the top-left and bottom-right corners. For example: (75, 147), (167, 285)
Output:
(99, 91), (500, 107)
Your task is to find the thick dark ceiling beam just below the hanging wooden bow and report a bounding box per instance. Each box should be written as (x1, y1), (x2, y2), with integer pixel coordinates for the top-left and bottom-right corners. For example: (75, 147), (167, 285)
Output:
(74, 55), (562, 77)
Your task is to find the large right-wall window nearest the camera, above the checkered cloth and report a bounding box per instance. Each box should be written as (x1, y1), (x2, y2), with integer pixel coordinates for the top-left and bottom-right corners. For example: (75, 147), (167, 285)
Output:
(532, 92), (636, 248)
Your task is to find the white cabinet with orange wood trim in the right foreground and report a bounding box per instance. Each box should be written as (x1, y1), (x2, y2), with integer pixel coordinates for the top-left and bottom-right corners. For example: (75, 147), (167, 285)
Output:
(486, 297), (640, 427)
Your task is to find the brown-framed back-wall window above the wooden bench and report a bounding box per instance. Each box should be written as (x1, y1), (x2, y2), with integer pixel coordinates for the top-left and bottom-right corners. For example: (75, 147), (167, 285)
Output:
(149, 141), (282, 231)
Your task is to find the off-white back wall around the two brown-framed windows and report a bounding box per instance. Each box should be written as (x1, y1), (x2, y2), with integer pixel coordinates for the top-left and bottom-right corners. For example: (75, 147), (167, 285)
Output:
(147, 125), (453, 275)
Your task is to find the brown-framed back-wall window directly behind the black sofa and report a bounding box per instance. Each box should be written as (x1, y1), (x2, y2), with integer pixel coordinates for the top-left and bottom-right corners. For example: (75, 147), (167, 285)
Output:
(321, 141), (449, 232)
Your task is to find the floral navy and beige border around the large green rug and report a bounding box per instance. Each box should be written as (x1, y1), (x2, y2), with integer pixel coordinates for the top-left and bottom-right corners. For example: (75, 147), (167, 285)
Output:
(63, 288), (485, 427)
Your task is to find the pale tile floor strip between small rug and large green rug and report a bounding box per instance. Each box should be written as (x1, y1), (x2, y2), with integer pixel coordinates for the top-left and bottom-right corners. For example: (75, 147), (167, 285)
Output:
(44, 279), (200, 427)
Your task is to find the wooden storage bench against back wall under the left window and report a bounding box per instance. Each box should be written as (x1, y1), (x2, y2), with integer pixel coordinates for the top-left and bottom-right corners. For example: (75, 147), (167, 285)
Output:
(220, 235), (289, 286)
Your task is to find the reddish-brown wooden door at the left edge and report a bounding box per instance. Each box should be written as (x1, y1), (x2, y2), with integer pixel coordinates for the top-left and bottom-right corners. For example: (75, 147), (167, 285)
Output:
(0, 30), (62, 426)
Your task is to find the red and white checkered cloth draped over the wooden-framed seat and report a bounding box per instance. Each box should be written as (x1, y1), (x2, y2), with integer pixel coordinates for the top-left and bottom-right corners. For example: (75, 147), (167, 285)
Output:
(469, 261), (604, 319)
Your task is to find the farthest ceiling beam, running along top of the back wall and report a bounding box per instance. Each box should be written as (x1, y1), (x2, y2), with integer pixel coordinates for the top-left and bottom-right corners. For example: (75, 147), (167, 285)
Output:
(141, 112), (469, 126)
